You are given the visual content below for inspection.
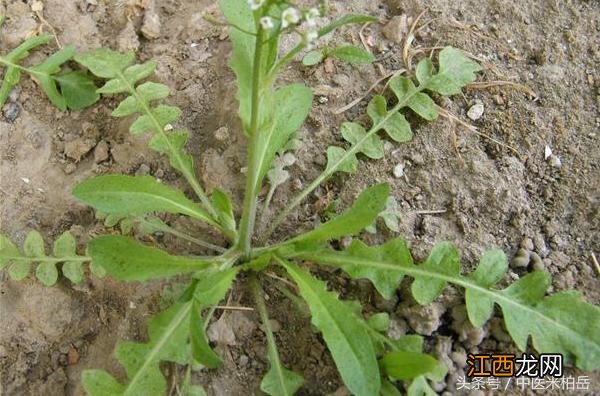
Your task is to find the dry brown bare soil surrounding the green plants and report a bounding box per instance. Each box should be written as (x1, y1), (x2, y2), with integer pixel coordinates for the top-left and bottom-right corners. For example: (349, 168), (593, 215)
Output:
(0, 0), (600, 395)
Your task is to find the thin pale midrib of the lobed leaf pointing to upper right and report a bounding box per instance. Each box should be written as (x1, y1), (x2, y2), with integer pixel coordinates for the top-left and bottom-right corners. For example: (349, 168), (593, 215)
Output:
(265, 87), (424, 239)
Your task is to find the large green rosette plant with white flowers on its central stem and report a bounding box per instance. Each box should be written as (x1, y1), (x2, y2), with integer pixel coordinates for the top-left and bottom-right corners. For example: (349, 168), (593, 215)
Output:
(0, 0), (600, 396)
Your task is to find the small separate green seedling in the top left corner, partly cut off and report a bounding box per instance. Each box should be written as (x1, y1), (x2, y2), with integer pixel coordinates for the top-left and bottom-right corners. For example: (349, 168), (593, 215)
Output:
(0, 16), (100, 111)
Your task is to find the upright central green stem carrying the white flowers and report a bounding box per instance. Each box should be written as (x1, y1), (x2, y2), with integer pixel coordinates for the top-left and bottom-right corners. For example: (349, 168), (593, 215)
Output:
(238, 24), (264, 259)
